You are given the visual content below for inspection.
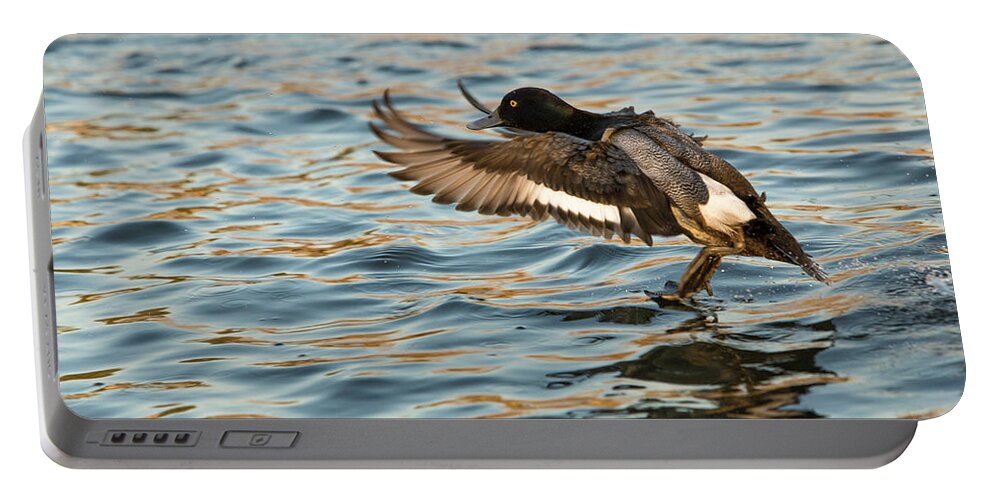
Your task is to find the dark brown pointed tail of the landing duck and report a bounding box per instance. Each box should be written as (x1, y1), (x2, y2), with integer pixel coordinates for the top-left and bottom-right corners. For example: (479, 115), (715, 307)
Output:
(744, 213), (830, 283)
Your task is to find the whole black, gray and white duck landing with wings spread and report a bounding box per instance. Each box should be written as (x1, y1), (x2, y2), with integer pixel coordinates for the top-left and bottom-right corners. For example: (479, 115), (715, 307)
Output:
(369, 80), (829, 303)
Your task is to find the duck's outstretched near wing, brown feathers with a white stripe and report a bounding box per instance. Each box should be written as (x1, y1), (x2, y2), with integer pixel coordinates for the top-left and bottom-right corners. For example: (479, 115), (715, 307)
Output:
(369, 94), (682, 245)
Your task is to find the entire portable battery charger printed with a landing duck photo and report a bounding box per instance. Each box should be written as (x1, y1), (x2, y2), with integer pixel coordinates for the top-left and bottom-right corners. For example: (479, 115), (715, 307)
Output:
(24, 34), (965, 468)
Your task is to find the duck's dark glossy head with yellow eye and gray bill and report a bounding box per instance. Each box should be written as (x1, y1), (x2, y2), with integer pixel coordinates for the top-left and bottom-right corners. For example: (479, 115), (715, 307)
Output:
(466, 87), (590, 132)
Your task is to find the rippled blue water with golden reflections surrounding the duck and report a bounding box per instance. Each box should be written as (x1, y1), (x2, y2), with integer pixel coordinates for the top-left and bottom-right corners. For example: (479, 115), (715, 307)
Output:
(45, 35), (965, 418)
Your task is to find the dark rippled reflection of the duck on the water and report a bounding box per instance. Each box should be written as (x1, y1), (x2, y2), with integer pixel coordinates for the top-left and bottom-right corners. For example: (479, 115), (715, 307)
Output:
(548, 307), (844, 418)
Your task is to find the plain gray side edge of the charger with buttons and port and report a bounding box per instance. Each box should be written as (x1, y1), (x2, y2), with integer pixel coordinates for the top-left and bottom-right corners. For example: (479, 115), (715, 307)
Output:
(24, 99), (917, 468)
